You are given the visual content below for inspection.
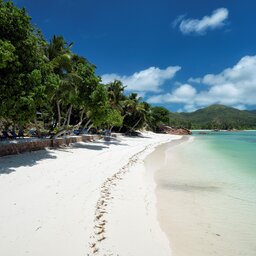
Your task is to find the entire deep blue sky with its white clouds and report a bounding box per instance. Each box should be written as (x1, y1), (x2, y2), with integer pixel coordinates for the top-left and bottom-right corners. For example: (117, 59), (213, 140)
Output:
(15, 0), (256, 111)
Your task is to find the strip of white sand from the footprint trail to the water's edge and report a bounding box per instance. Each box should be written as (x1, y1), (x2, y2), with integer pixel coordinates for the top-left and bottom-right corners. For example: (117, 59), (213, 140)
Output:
(90, 135), (182, 256)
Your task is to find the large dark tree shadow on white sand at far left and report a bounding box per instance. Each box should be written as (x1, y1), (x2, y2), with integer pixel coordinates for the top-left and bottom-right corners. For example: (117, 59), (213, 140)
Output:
(0, 150), (57, 175)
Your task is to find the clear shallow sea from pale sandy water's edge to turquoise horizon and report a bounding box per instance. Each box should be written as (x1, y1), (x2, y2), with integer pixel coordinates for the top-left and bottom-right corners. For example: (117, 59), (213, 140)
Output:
(150, 132), (256, 256)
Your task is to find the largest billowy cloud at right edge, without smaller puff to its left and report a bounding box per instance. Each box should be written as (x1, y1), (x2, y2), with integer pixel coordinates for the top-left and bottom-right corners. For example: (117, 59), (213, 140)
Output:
(197, 55), (256, 105)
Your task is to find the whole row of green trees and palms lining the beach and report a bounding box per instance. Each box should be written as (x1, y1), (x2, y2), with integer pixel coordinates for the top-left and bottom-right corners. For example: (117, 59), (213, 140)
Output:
(0, 0), (172, 135)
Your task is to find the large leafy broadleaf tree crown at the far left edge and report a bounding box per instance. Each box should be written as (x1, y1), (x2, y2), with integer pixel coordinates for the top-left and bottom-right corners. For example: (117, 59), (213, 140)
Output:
(0, 1), (51, 126)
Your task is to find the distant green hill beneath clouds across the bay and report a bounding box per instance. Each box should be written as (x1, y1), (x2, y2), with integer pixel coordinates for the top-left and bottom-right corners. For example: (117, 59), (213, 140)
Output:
(170, 105), (256, 129)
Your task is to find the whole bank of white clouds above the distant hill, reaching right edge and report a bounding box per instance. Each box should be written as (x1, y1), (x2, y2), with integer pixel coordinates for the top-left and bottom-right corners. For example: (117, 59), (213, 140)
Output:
(148, 55), (256, 111)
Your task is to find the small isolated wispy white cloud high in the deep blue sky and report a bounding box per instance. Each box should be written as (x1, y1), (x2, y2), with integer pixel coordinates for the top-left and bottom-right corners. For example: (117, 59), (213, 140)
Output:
(173, 8), (229, 35)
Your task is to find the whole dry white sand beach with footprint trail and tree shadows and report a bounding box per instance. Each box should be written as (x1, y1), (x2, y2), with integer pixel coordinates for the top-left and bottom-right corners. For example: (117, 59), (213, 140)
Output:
(0, 133), (180, 256)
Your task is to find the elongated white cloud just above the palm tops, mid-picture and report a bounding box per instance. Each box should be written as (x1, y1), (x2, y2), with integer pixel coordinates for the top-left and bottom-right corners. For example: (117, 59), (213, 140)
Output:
(101, 66), (181, 92)
